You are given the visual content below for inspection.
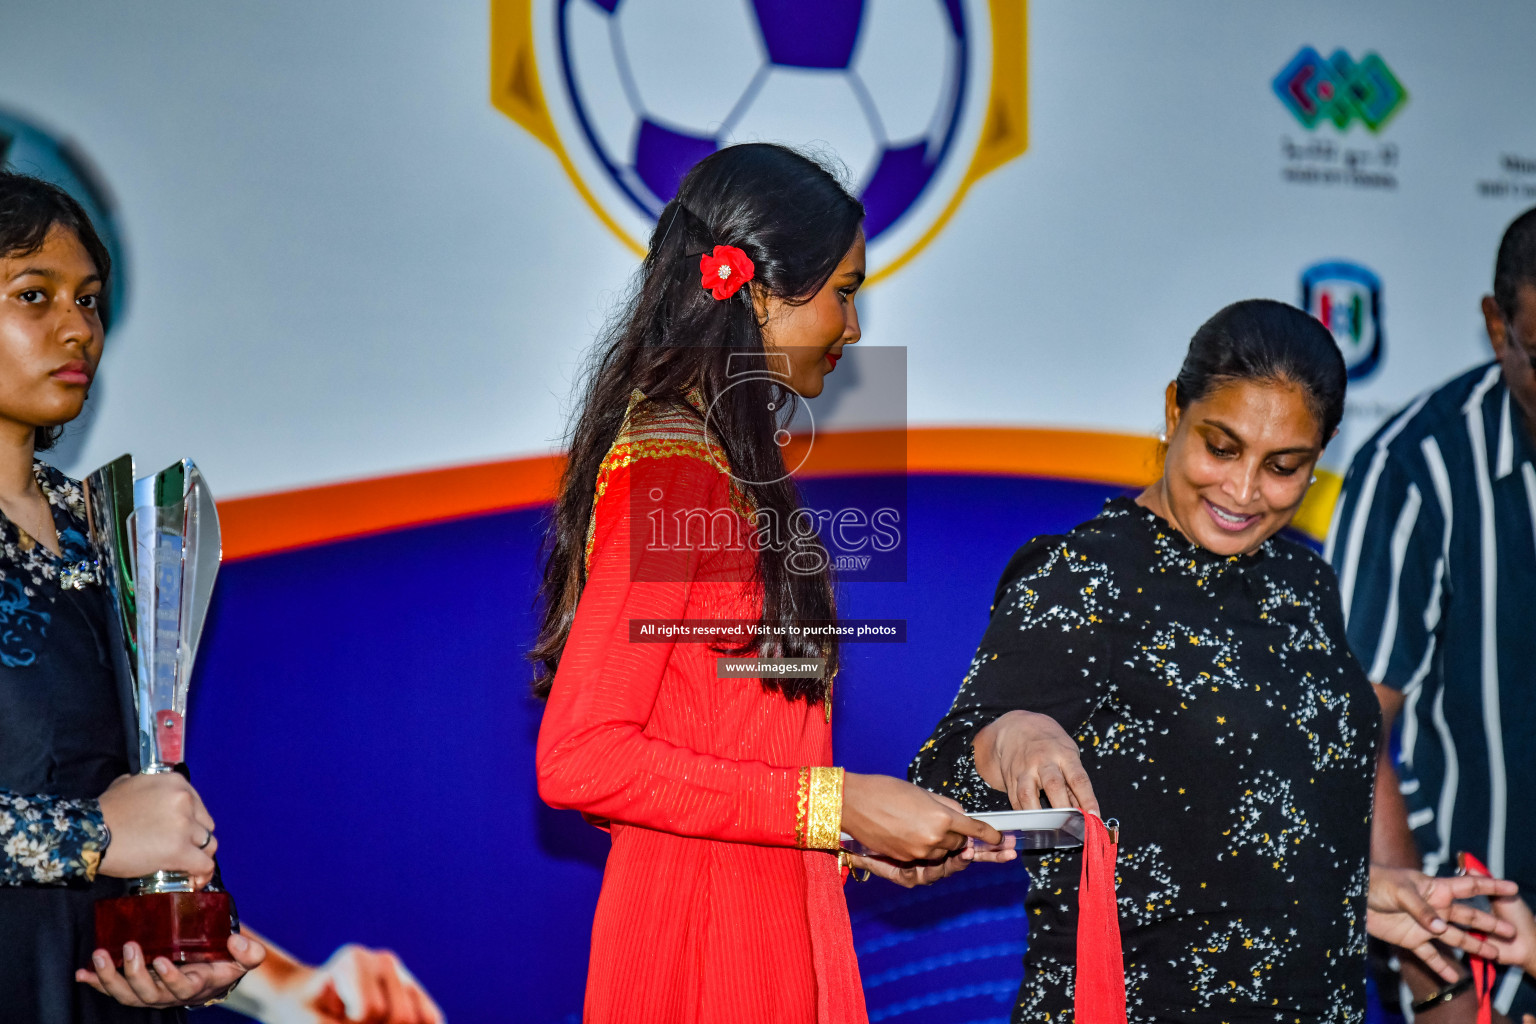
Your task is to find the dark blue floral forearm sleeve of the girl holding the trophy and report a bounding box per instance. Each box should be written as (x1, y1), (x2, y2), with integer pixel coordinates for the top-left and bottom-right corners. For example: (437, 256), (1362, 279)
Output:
(0, 789), (112, 886)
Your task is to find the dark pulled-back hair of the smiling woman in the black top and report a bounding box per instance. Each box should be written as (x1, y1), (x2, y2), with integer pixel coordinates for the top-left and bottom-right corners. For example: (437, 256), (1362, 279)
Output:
(1174, 299), (1349, 445)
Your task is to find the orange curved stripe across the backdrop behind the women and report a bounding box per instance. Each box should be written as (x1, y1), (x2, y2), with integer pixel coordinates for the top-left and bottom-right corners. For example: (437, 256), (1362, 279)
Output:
(218, 427), (1338, 560)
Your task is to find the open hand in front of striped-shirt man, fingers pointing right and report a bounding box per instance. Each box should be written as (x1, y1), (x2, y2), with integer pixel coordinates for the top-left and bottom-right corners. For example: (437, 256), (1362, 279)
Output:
(1366, 864), (1519, 981)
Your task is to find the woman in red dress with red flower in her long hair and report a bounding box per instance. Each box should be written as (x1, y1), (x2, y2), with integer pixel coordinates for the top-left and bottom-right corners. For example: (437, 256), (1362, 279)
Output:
(533, 144), (1012, 1024)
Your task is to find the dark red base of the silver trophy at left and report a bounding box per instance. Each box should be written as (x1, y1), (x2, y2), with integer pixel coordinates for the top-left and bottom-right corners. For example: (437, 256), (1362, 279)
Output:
(95, 892), (230, 967)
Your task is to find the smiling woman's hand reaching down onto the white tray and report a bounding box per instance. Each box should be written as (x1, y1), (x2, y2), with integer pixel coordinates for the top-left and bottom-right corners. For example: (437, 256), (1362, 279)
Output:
(974, 711), (1098, 814)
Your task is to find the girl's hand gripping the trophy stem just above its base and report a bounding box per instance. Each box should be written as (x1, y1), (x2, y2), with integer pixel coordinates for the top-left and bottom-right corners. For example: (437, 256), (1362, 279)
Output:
(98, 772), (218, 889)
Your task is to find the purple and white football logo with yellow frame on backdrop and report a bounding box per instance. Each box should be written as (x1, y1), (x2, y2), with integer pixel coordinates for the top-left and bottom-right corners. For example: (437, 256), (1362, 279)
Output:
(492, 0), (1026, 278)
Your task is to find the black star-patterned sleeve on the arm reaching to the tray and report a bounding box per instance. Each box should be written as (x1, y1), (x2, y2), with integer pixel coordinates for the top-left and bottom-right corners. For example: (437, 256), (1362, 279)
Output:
(908, 537), (1117, 812)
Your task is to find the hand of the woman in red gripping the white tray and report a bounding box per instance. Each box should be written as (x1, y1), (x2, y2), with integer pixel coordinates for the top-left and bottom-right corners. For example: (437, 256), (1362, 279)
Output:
(843, 772), (1003, 870)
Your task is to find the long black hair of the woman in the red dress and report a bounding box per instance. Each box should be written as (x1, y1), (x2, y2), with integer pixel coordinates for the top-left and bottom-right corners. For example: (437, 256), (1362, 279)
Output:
(530, 143), (863, 702)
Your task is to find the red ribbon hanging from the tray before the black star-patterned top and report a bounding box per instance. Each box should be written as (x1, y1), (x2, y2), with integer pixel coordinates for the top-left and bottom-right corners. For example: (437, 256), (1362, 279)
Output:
(1072, 812), (1126, 1024)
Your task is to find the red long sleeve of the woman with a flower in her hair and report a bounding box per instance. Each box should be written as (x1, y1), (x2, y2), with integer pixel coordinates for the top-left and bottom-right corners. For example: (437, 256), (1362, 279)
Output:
(538, 454), (806, 846)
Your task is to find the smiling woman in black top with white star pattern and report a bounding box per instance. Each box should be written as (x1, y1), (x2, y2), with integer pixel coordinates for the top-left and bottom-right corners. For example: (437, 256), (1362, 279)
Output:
(911, 301), (1507, 1024)
